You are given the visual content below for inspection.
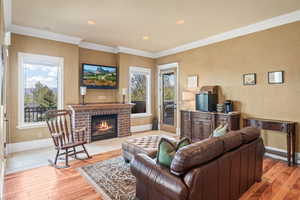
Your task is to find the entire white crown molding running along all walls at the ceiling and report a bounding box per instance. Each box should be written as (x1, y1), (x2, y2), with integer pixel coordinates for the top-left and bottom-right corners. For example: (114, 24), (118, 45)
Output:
(4, 7), (300, 58)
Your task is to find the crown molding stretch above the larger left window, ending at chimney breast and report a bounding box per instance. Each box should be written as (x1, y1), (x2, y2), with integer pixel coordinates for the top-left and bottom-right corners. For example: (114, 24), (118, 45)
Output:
(8, 24), (82, 45)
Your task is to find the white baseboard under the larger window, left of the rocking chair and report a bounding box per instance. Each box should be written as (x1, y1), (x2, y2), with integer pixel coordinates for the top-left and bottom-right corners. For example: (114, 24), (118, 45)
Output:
(7, 138), (53, 154)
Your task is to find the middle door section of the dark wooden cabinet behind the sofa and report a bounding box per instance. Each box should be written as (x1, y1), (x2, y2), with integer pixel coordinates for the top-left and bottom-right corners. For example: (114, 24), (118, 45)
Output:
(192, 120), (212, 142)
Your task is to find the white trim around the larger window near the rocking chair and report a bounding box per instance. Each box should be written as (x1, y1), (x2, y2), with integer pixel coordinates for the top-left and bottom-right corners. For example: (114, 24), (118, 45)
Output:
(17, 52), (64, 129)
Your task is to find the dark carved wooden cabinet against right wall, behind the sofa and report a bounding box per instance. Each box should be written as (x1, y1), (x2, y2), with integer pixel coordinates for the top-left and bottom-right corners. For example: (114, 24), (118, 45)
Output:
(180, 110), (240, 142)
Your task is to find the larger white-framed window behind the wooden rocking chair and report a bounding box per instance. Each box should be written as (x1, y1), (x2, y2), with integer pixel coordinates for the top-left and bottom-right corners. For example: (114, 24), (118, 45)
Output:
(18, 53), (63, 128)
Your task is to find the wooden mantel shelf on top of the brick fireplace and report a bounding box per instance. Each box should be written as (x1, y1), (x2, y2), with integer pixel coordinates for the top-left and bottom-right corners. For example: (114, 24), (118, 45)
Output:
(68, 103), (134, 111)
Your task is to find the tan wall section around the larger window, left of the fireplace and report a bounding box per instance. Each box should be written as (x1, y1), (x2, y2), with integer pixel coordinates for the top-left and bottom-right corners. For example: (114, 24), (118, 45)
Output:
(8, 34), (79, 143)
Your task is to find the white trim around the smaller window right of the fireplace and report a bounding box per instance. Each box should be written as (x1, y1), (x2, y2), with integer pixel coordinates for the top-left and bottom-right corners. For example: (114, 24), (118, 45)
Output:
(128, 67), (152, 118)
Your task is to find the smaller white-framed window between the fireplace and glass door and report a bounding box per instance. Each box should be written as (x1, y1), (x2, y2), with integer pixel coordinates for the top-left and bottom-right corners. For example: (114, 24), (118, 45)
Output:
(129, 67), (151, 117)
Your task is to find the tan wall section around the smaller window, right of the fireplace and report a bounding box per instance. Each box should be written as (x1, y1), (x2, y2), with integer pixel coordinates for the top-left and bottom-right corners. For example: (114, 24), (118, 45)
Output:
(118, 53), (156, 126)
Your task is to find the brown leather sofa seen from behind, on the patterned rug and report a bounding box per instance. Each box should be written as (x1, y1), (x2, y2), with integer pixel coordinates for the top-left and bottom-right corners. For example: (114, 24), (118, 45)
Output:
(131, 127), (264, 200)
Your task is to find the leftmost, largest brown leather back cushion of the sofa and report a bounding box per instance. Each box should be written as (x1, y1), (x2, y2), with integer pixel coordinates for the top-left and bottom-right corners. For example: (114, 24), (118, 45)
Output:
(170, 137), (224, 175)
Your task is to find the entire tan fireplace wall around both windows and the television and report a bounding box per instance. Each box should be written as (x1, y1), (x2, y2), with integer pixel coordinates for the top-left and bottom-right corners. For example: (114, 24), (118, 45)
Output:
(7, 34), (155, 143)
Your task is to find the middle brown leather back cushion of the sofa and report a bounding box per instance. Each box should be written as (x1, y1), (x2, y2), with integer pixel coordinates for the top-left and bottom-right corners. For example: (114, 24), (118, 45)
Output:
(219, 131), (242, 152)
